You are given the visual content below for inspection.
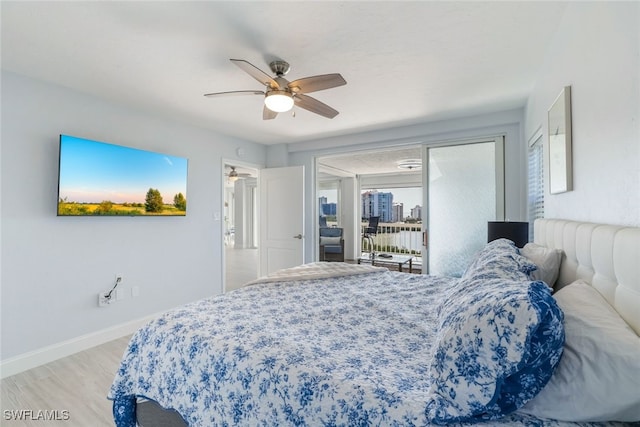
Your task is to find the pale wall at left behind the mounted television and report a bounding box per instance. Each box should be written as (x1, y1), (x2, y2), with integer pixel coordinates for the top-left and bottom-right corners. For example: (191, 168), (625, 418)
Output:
(1, 72), (266, 364)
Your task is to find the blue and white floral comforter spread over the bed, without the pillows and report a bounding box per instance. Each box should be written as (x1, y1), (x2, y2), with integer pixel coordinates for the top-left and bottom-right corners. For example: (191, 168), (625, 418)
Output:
(109, 271), (632, 427)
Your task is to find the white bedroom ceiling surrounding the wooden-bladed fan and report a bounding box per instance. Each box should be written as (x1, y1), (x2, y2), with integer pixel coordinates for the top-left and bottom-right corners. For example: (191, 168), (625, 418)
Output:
(0, 0), (565, 148)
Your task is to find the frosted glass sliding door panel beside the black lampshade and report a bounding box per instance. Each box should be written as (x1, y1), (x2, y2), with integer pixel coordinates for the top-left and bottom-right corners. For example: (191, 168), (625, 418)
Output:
(423, 137), (504, 276)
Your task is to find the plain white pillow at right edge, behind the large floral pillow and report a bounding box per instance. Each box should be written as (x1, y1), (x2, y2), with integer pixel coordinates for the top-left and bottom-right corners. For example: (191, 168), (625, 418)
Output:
(520, 280), (640, 421)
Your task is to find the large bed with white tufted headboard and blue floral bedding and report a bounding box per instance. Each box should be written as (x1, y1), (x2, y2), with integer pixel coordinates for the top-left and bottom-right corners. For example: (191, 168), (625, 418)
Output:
(108, 219), (640, 427)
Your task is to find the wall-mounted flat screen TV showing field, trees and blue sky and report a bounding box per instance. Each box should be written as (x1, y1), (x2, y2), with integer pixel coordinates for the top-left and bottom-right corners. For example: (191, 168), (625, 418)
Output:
(58, 135), (187, 216)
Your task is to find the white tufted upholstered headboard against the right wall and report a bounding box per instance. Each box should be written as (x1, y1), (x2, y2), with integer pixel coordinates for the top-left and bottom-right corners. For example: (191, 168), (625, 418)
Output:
(533, 219), (640, 335)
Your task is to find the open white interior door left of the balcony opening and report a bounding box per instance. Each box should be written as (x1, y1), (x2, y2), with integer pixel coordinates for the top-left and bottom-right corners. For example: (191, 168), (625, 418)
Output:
(258, 166), (305, 276)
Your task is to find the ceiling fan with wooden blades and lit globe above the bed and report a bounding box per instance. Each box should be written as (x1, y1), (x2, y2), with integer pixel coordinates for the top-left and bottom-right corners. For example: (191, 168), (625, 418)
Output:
(204, 59), (347, 120)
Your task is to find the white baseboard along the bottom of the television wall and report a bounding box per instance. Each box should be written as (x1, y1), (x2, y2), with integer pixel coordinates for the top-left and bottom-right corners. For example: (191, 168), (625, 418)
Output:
(0, 314), (158, 378)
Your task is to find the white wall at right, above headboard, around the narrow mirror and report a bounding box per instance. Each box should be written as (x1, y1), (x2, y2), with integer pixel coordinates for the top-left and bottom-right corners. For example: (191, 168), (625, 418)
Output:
(525, 2), (640, 226)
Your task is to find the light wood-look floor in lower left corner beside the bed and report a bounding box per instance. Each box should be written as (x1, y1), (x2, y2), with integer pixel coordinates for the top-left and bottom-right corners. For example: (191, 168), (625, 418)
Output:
(0, 336), (131, 427)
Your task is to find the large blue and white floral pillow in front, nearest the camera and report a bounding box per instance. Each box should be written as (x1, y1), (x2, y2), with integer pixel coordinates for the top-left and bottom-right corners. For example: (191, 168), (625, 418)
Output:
(426, 277), (564, 424)
